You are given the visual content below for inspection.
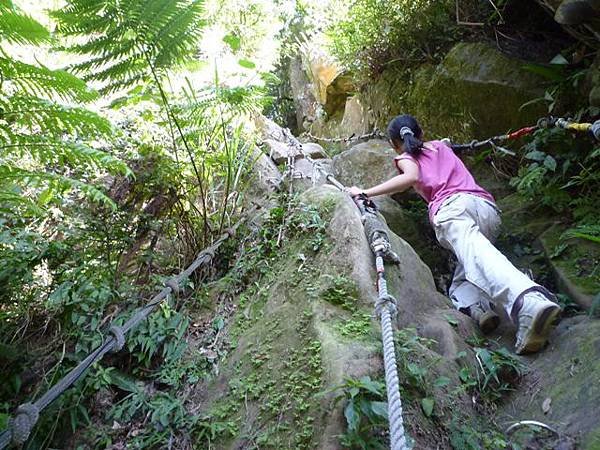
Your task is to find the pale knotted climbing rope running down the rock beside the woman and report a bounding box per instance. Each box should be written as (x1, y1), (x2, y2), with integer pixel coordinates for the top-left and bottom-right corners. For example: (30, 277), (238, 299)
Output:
(284, 129), (410, 450)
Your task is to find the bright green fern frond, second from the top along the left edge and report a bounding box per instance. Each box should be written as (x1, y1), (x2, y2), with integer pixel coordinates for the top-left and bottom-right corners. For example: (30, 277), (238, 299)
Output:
(0, 57), (98, 102)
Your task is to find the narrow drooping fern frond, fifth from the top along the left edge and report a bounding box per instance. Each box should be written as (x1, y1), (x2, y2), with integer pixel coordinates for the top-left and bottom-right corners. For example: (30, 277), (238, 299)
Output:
(0, 164), (117, 210)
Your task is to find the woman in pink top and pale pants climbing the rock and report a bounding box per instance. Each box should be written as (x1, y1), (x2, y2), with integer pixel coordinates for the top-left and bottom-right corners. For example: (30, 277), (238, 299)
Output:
(348, 115), (560, 354)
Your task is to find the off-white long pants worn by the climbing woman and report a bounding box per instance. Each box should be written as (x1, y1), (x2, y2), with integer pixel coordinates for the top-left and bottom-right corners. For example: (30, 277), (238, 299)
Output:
(433, 194), (544, 317)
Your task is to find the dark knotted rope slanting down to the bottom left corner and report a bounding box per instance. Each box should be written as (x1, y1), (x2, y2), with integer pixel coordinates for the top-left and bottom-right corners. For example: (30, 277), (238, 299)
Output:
(0, 221), (243, 449)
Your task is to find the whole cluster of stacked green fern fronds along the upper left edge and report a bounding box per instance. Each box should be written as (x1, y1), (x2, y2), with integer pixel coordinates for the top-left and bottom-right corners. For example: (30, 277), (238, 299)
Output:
(0, 1), (129, 216)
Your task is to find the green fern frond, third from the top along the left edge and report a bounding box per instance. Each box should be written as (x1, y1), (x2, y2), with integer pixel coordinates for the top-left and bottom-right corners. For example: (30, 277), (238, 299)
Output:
(0, 95), (113, 138)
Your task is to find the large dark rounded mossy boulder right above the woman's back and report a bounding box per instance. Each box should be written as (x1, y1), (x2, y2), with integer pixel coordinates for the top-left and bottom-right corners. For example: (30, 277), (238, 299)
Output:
(407, 43), (547, 140)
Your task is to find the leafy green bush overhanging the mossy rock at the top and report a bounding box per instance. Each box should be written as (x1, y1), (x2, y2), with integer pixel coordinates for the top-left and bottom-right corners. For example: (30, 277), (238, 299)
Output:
(328, 0), (455, 77)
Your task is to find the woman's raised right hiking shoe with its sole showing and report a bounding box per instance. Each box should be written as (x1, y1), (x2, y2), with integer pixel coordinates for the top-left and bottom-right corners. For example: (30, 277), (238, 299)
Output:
(515, 292), (561, 355)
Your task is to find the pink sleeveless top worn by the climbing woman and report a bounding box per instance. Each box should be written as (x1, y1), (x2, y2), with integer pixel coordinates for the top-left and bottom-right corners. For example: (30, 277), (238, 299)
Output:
(394, 141), (494, 222)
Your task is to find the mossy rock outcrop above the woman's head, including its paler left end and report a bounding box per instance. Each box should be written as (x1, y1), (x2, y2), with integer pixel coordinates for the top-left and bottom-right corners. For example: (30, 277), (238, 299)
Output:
(304, 43), (547, 141)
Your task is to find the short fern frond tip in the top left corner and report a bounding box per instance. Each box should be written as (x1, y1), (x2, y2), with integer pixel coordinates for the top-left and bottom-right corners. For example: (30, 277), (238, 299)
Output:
(0, 0), (52, 45)
